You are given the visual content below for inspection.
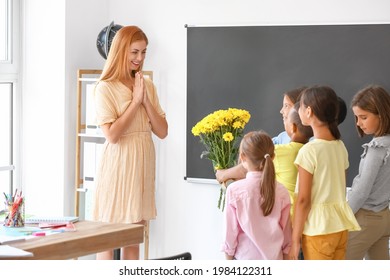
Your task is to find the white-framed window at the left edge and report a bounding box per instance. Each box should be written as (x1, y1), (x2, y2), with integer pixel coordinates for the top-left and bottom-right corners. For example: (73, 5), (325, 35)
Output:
(0, 0), (19, 199)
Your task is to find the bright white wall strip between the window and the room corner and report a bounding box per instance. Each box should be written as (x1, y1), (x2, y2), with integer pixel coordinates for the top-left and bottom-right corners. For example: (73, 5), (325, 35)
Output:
(21, 0), (68, 214)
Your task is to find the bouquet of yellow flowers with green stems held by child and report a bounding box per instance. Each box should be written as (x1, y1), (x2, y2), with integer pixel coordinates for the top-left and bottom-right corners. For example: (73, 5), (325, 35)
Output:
(191, 108), (251, 211)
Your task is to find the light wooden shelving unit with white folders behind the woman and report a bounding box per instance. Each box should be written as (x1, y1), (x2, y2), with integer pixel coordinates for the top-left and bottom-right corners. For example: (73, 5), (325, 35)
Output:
(75, 69), (153, 259)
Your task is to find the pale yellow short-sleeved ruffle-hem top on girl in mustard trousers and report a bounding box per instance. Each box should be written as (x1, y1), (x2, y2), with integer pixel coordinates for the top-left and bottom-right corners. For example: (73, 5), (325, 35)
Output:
(295, 139), (360, 236)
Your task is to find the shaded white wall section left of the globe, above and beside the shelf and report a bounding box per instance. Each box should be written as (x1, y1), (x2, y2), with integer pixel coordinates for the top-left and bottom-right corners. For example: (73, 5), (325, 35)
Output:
(63, 0), (108, 213)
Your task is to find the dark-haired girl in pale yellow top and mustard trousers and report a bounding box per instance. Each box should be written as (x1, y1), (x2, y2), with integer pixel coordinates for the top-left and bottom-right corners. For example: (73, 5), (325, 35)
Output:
(289, 86), (360, 260)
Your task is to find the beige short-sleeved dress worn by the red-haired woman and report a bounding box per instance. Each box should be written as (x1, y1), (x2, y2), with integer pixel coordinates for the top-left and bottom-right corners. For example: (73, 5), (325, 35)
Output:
(93, 78), (165, 223)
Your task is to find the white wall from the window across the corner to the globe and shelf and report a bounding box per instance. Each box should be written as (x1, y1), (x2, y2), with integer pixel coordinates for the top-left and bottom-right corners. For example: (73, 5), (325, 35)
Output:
(22, 0), (108, 215)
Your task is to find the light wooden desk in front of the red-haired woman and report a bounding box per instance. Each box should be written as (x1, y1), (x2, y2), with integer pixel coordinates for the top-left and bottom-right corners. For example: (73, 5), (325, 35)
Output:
(3, 221), (144, 260)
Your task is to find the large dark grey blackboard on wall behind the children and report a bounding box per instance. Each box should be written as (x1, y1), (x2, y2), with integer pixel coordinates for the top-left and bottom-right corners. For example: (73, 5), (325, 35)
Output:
(185, 24), (390, 185)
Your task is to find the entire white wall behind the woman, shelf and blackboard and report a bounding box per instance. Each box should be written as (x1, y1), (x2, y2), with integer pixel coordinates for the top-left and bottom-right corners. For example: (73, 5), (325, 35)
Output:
(20, 0), (390, 260)
